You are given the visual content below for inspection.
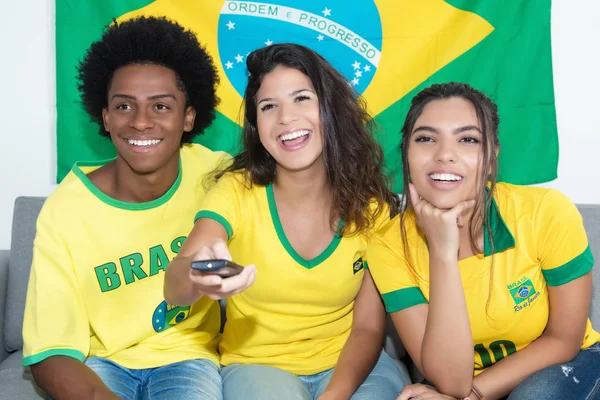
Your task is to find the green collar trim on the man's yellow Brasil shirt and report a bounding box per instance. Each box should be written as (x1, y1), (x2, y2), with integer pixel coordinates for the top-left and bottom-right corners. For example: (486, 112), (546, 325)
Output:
(71, 156), (182, 211)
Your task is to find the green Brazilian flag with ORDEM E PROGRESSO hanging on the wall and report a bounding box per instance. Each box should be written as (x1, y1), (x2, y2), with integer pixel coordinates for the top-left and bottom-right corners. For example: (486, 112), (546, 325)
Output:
(56, 0), (558, 190)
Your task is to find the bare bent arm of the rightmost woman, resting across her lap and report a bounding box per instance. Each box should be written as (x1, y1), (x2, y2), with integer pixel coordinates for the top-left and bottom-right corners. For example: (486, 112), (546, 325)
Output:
(473, 272), (592, 400)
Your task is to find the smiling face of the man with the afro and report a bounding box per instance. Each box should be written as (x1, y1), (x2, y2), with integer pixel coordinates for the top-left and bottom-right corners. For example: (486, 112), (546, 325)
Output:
(102, 64), (195, 174)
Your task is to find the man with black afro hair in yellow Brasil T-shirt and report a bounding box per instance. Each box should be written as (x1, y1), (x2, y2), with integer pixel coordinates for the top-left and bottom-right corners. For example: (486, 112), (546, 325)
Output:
(23, 17), (233, 400)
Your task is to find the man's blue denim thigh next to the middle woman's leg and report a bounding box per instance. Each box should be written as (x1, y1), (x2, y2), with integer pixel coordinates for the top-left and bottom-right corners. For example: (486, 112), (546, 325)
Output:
(142, 360), (223, 400)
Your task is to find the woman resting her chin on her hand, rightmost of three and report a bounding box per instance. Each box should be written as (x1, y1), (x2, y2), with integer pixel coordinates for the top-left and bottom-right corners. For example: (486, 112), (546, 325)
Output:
(367, 83), (600, 400)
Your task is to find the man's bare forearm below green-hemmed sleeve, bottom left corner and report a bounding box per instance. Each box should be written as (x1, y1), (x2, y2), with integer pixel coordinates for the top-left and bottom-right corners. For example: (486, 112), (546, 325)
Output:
(31, 356), (119, 400)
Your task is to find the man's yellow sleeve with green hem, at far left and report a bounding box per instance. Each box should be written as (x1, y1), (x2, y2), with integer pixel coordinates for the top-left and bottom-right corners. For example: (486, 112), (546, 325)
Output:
(23, 203), (90, 366)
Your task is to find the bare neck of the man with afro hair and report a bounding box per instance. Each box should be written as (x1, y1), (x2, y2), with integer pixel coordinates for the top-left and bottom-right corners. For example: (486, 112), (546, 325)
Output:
(113, 152), (179, 203)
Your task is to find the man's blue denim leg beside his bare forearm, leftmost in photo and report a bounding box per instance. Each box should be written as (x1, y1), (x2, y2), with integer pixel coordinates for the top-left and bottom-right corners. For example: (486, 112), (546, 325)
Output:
(85, 357), (141, 400)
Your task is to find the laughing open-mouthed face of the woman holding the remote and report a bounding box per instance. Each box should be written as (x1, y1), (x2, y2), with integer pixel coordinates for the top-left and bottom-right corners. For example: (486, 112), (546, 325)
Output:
(256, 66), (323, 171)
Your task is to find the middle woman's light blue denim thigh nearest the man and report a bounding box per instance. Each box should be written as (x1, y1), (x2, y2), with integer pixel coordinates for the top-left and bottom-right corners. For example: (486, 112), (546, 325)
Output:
(221, 364), (312, 400)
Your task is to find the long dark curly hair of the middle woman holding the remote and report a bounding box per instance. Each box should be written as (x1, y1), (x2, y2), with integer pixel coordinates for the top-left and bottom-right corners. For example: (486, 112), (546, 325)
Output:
(216, 43), (399, 235)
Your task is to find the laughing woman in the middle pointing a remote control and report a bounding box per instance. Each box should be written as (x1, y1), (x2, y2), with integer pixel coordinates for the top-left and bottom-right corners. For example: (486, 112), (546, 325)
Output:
(165, 44), (407, 400)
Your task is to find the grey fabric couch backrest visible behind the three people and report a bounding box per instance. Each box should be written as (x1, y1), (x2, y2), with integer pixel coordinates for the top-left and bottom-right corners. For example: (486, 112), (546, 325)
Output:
(4, 197), (600, 356)
